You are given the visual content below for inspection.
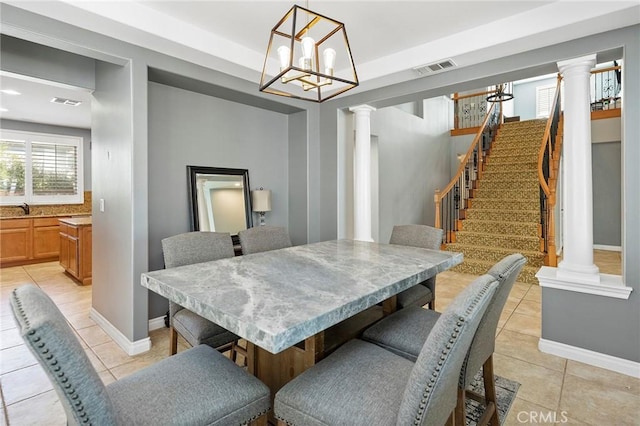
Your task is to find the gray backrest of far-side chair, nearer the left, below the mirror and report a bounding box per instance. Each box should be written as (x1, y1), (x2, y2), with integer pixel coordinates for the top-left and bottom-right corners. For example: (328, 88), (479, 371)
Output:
(162, 231), (234, 268)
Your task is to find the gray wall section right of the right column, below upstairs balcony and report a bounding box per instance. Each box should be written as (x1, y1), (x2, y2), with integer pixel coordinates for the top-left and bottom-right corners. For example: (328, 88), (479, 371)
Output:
(591, 142), (622, 247)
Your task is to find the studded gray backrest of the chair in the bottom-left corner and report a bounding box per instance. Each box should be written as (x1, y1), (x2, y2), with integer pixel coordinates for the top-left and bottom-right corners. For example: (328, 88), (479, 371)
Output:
(11, 284), (118, 425)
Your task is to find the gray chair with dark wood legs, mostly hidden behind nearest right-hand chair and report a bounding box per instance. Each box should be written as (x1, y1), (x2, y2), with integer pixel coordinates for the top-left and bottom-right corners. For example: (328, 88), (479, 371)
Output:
(362, 253), (527, 425)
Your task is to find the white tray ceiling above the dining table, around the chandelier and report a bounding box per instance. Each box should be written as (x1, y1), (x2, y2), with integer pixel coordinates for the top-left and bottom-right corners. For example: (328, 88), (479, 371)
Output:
(1, 0), (640, 127)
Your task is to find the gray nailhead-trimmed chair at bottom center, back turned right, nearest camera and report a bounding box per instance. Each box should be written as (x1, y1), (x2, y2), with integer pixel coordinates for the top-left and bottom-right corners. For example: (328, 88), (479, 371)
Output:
(274, 275), (497, 426)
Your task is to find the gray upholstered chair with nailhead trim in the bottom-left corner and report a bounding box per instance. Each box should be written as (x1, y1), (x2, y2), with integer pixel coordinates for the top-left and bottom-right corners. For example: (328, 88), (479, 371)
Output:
(10, 284), (270, 426)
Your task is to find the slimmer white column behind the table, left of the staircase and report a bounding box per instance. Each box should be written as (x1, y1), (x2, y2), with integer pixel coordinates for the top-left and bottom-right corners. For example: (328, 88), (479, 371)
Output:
(349, 105), (376, 241)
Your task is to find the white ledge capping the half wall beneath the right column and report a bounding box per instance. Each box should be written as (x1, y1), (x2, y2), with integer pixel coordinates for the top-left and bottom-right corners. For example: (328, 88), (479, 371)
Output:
(536, 266), (633, 299)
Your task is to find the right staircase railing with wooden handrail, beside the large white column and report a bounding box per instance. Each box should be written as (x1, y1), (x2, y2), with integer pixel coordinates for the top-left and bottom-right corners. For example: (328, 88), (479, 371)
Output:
(538, 74), (562, 266)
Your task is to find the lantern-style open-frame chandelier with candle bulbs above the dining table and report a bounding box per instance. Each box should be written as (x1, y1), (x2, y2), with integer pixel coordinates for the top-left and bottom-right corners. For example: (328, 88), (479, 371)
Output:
(260, 5), (358, 102)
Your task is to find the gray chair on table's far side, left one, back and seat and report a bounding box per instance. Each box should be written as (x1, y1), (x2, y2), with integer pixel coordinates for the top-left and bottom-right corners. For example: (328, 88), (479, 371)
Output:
(162, 232), (239, 359)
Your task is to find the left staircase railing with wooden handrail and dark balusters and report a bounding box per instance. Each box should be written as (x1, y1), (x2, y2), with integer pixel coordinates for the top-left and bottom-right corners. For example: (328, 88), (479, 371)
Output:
(434, 98), (502, 244)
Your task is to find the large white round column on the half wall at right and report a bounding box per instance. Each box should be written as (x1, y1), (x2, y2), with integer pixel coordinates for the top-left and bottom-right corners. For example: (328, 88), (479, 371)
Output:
(557, 55), (600, 283)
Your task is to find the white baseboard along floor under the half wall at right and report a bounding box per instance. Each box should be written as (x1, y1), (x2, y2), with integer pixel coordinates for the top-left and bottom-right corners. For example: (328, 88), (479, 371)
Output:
(538, 339), (640, 379)
